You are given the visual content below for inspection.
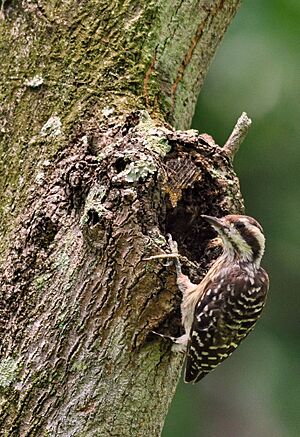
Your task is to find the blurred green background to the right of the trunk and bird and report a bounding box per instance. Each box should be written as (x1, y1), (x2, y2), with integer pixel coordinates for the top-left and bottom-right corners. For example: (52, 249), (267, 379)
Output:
(163, 0), (300, 437)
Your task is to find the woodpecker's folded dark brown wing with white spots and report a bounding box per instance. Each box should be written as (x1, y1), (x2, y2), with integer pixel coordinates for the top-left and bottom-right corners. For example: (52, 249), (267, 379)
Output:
(185, 272), (268, 383)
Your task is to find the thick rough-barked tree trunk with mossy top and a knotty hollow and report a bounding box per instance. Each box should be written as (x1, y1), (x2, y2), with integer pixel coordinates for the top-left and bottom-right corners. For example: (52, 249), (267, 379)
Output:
(0, 0), (243, 437)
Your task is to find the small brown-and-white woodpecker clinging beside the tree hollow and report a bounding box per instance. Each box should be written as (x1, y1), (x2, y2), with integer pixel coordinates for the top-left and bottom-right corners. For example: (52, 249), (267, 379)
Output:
(166, 215), (269, 383)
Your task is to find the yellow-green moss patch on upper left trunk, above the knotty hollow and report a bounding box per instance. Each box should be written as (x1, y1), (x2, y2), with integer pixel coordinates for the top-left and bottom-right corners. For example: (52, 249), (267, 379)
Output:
(0, 1), (163, 244)
